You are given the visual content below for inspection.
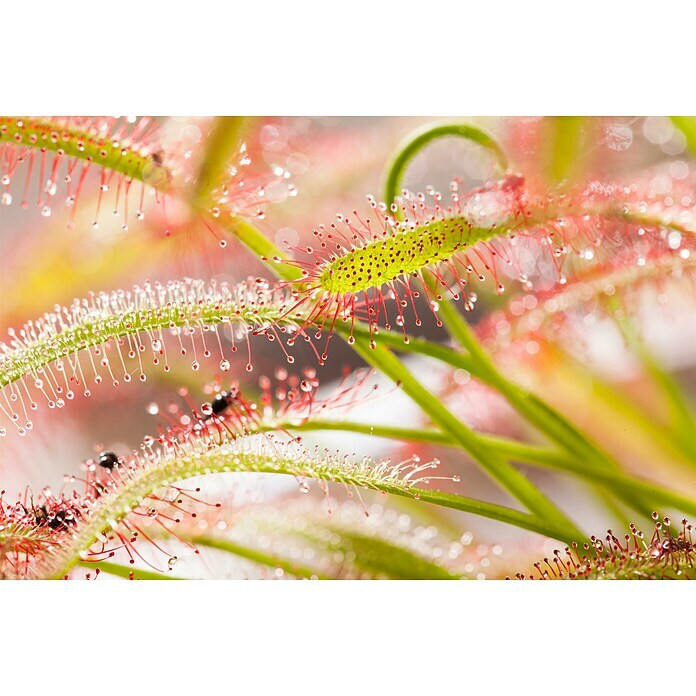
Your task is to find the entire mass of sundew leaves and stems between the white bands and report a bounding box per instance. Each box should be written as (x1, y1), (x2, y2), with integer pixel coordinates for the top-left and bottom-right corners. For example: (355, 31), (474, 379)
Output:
(0, 116), (696, 581)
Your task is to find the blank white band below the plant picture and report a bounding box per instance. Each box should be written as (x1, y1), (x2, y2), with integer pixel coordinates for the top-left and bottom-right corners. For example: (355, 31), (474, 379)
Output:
(0, 581), (696, 695)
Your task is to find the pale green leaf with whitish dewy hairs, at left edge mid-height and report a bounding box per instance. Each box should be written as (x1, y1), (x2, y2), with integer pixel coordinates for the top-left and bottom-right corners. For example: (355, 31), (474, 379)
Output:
(0, 279), (316, 435)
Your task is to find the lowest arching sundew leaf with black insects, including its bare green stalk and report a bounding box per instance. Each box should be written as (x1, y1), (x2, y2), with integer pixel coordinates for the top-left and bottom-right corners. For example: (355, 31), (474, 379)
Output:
(2, 386), (578, 578)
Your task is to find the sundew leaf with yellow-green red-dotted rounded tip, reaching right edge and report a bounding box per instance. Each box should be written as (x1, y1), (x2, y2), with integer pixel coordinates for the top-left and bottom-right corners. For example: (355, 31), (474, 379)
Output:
(278, 171), (696, 357)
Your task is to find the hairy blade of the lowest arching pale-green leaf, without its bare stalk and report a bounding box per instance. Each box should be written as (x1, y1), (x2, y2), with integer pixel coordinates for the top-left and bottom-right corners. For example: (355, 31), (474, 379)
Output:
(17, 421), (462, 578)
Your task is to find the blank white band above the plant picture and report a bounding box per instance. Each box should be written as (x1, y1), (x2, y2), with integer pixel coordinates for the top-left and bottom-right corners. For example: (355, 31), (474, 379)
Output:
(5, 0), (696, 116)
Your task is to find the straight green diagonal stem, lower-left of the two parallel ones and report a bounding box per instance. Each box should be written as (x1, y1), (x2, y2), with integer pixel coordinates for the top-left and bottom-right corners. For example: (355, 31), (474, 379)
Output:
(353, 337), (582, 537)
